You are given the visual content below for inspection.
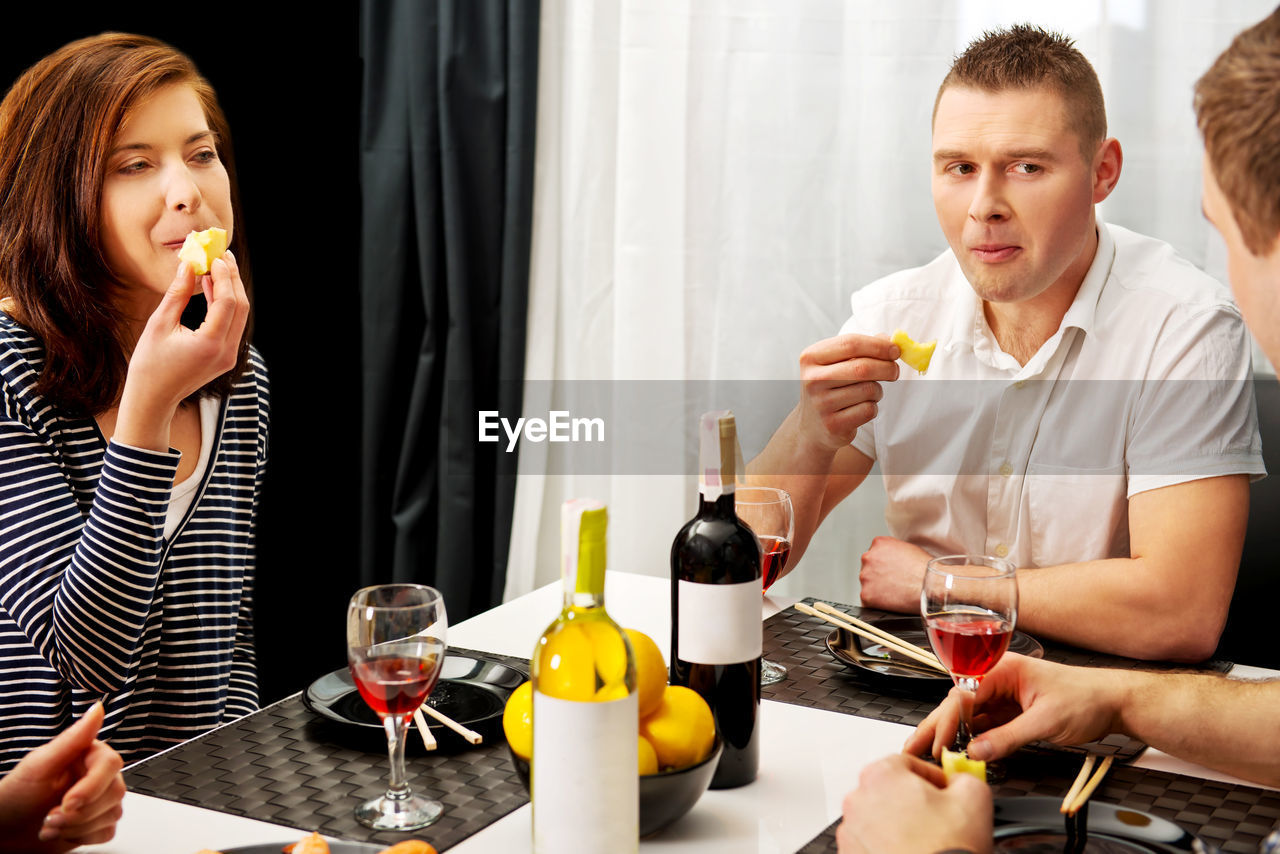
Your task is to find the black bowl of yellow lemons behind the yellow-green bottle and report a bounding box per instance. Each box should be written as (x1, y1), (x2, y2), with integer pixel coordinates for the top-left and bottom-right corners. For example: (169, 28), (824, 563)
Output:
(503, 629), (723, 836)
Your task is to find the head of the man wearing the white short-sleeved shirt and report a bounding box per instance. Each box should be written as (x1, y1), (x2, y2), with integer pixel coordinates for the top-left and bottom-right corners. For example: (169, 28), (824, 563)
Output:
(932, 24), (1123, 311)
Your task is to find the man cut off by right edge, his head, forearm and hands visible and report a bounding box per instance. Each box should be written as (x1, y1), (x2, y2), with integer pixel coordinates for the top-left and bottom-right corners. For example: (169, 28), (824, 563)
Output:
(837, 10), (1280, 854)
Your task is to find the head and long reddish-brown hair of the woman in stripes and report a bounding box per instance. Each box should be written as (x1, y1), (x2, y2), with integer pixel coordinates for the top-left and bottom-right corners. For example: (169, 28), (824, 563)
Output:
(0, 33), (252, 416)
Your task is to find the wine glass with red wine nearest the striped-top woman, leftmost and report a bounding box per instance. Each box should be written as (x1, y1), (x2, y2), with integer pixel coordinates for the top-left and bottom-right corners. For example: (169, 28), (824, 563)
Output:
(347, 584), (448, 830)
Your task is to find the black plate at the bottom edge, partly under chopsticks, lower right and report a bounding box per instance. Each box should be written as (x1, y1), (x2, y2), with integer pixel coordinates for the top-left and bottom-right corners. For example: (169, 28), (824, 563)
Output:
(995, 798), (1213, 854)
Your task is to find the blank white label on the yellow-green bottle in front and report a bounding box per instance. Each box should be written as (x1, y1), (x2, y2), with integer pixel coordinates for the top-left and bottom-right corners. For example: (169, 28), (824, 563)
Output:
(530, 691), (640, 854)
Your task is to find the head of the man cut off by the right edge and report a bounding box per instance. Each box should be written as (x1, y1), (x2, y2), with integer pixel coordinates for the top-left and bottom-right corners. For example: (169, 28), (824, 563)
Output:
(1194, 8), (1280, 366)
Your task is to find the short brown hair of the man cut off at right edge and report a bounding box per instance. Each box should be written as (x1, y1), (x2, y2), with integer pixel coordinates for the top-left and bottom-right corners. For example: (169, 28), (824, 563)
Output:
(1196, 9), (1280, 255)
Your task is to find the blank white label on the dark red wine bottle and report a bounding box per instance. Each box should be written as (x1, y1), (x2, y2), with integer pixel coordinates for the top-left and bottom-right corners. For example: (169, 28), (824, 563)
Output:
(672, 579), (764, 665)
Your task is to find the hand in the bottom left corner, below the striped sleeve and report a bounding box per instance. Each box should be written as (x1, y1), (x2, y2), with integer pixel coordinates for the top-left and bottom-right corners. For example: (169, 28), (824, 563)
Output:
(0, 703), (124, 853)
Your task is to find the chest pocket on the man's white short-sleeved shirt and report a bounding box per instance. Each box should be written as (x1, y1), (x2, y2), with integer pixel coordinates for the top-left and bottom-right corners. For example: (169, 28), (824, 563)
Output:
(1027, 463), (1129, 566)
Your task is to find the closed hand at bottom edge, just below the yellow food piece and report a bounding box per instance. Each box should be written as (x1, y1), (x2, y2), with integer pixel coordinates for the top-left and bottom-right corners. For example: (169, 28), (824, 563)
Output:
(836, 754), (992, 854)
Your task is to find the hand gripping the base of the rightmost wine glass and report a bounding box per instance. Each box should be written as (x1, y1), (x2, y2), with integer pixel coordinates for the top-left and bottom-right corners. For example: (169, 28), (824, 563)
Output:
(902, 653), (1124, 761)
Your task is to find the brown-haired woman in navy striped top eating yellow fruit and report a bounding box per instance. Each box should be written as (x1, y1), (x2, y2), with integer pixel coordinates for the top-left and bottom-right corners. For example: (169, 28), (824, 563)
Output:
(0, 33), (269, 773)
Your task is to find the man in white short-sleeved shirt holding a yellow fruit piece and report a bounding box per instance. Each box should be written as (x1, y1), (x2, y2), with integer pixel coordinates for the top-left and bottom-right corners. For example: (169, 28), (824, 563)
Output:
(751, 21), (1263, 661)
